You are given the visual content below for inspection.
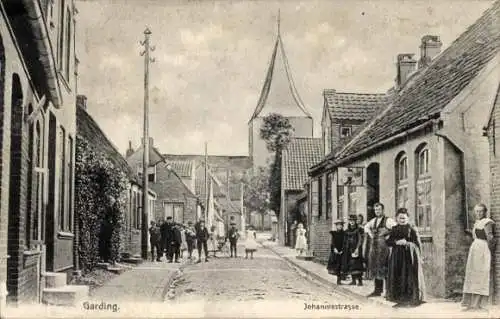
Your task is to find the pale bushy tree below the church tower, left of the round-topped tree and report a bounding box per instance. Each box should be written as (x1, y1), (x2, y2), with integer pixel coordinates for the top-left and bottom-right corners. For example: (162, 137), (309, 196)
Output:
(242, 167), (269, 231)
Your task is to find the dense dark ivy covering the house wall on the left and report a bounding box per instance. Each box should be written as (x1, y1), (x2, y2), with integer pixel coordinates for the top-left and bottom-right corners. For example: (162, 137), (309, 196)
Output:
(75, 136), (128, 272)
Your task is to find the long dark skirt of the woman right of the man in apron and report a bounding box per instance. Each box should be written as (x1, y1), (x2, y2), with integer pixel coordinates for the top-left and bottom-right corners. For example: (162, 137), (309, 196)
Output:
(386, 243), (425, 305)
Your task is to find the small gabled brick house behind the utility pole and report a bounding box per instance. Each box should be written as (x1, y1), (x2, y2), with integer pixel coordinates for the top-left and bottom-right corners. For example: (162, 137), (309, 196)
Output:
(127, 138), (201, 223)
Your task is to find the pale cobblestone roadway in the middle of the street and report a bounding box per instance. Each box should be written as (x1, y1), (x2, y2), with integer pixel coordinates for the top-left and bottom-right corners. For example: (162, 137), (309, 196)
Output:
(170, 247), (357, 304)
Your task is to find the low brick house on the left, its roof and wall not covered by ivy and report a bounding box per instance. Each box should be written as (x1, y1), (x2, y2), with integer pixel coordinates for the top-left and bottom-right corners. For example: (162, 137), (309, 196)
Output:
(76, 95), (156, 256)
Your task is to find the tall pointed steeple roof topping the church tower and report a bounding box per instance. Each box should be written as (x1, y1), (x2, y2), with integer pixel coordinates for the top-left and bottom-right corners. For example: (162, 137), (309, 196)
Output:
(249, 11), (312, 122)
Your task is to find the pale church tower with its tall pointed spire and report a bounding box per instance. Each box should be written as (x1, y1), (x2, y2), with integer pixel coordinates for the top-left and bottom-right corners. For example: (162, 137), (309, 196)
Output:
(248, 13), (313, 168)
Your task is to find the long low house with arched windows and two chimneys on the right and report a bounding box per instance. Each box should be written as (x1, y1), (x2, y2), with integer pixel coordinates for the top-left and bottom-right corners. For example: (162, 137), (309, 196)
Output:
(310, 2), (500, 297)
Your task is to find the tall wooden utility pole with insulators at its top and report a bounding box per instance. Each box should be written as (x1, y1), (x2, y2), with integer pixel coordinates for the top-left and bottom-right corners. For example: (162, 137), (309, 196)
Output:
(140, 28), (155, 259)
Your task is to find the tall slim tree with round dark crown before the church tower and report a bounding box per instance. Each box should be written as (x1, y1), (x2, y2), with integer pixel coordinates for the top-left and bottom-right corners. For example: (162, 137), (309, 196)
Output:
(260, 113), (294, 216)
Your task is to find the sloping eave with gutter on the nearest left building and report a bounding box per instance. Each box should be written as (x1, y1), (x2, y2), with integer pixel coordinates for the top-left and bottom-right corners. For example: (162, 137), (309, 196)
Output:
(22, 0), (62, 108)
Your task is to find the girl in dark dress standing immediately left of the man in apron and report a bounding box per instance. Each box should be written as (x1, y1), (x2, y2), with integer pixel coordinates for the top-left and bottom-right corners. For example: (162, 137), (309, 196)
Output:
(343, 215), (365, 286)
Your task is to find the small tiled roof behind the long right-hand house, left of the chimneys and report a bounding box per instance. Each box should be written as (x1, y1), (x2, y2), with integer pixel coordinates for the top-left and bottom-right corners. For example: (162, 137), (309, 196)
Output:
(323, 90), (389, 121)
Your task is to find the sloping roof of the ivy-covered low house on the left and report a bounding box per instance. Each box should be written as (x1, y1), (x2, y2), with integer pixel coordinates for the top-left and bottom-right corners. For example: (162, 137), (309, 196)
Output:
(76, 107), (138, 182)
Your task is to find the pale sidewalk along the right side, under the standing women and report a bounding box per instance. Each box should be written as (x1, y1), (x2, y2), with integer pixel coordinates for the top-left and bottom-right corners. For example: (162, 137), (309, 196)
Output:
(261, 241), (500, 318)
